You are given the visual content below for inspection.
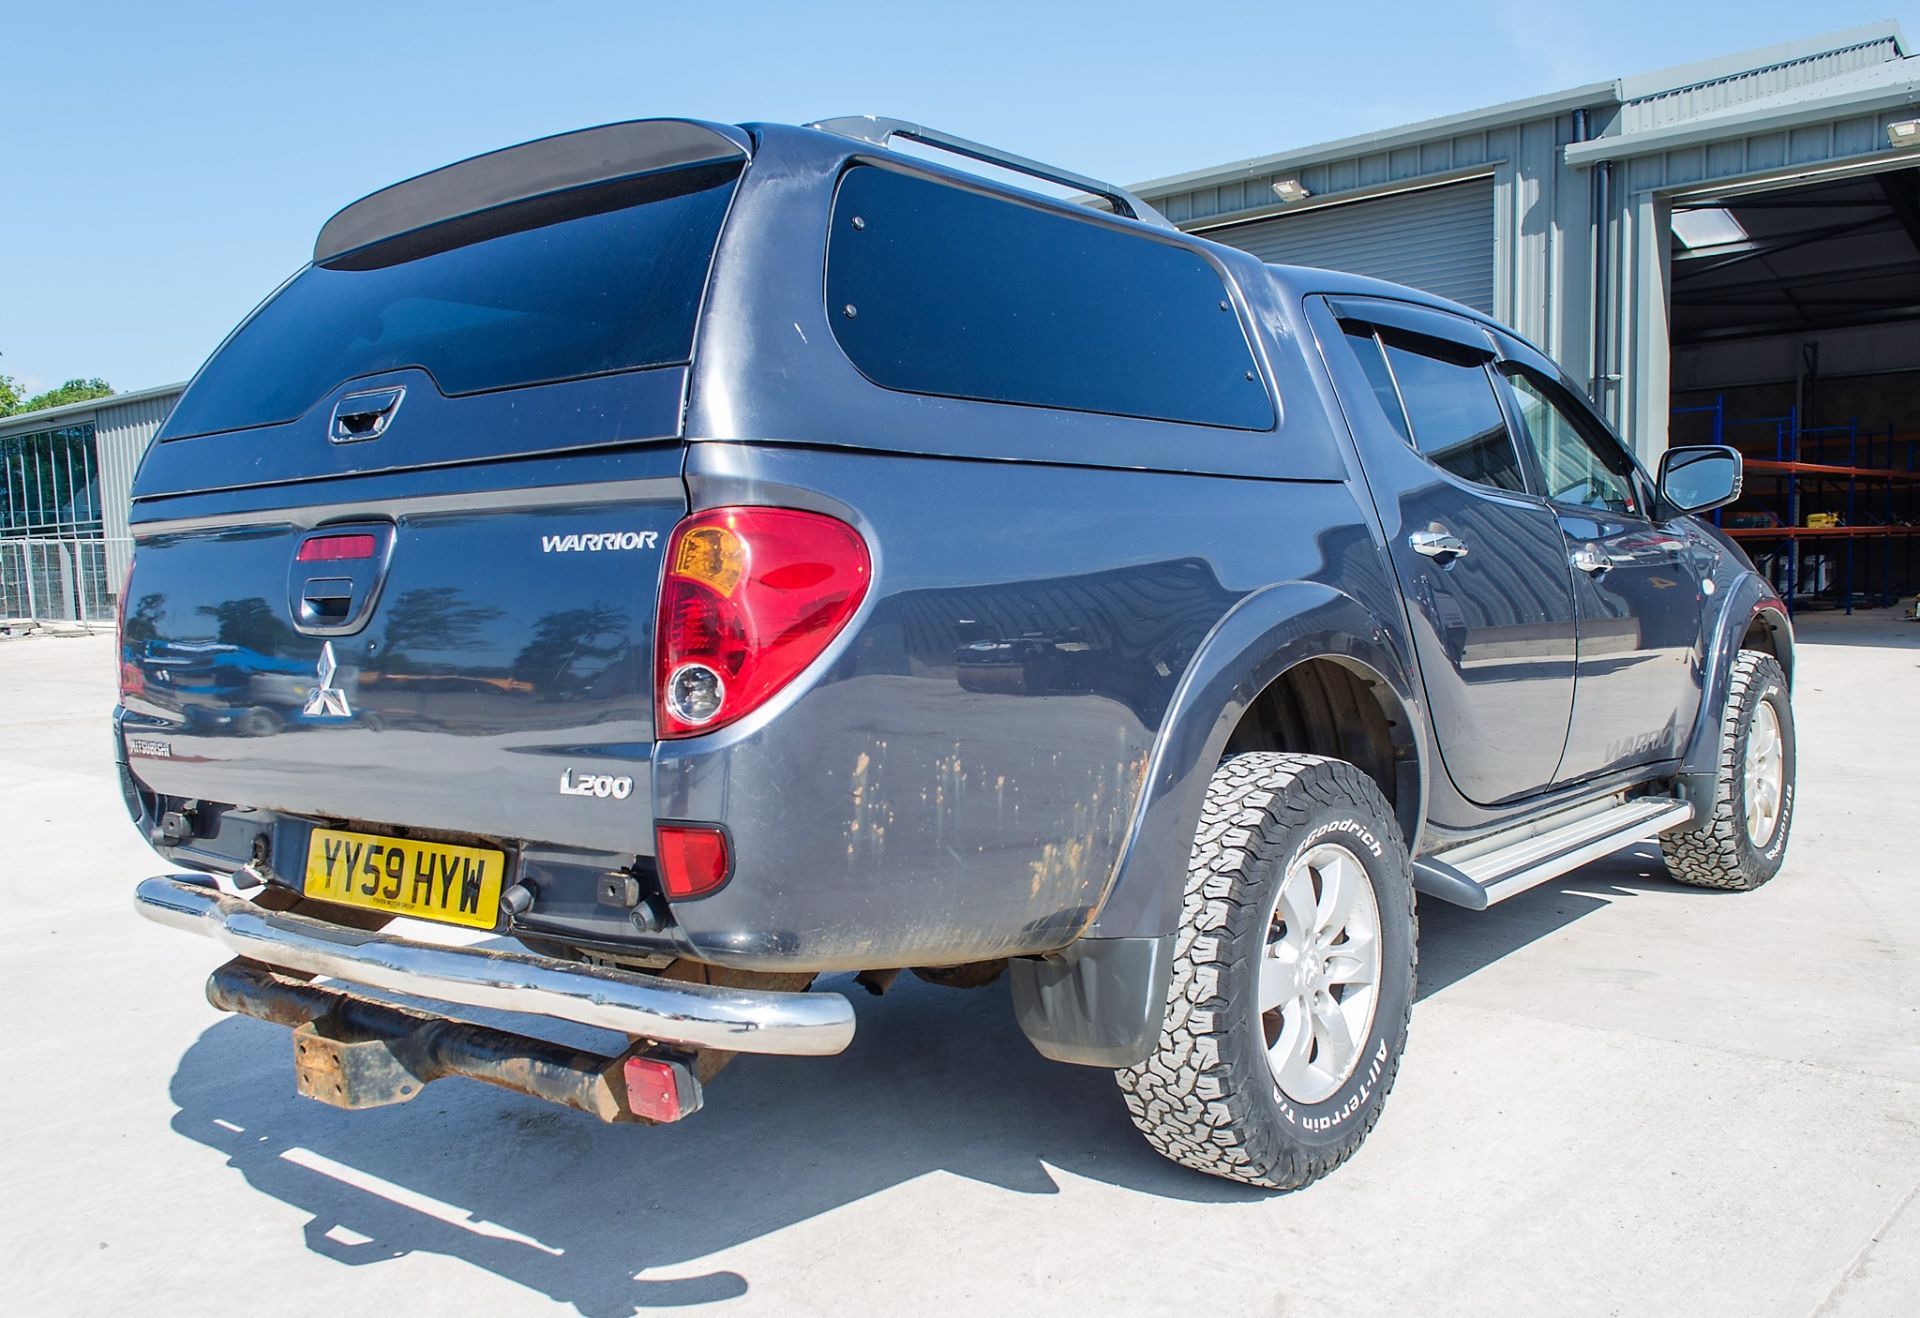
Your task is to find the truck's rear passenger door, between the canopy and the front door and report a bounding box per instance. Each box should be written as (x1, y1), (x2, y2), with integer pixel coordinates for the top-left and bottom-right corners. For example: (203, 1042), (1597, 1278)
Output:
(1313, 298), (1576, 805)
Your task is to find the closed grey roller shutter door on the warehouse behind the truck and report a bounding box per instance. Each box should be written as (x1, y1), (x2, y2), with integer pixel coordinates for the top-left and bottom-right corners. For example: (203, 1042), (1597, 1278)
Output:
(1206, 179), (1494, 315)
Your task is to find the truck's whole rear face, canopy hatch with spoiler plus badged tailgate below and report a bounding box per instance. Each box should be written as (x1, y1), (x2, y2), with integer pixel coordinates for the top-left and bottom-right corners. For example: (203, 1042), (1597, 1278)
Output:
(121, 136), (745, 855)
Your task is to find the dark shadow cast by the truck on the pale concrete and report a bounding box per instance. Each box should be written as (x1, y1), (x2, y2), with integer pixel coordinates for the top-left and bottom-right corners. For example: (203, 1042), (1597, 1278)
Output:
(171, 847), (1697, 1318)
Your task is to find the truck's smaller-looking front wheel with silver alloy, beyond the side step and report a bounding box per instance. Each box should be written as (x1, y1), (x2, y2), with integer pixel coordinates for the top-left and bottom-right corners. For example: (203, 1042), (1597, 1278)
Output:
(1661, 649), (1795, 891)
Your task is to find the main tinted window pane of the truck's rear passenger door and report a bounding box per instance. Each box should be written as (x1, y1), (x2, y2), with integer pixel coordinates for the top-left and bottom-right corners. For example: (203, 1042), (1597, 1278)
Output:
(1380, 330), (1526, 490)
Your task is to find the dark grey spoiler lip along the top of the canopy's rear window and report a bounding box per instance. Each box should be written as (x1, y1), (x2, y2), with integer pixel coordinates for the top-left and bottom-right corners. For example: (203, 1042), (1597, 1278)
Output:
(313, 119), (753, 265)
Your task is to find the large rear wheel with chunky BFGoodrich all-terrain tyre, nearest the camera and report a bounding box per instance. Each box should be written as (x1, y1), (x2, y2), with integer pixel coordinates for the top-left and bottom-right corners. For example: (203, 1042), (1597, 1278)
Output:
(1114, 751), (1417, 1189)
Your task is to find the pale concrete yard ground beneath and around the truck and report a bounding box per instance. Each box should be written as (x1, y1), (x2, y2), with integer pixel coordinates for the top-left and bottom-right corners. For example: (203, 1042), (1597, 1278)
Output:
(0, 613), (1920, 1318)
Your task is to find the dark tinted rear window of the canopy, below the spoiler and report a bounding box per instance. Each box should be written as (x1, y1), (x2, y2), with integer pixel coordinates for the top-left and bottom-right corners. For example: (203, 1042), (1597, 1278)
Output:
(167, 159), (741, 438)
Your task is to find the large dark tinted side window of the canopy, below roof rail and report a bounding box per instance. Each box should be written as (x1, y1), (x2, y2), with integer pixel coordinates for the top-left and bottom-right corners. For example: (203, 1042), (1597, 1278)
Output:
(826, 165), (1273, 430)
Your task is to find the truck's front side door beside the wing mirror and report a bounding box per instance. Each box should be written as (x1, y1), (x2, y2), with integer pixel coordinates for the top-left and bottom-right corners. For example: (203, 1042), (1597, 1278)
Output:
(1498, 336), (1703, 782)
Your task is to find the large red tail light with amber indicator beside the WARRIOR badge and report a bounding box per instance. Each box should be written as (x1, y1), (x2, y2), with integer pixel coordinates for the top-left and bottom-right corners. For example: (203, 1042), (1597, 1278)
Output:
(655, 507), (872, 738)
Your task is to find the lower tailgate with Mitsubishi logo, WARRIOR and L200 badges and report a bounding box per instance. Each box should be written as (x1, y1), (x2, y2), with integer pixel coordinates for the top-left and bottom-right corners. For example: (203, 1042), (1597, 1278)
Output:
(121, 434), (685, 853)
